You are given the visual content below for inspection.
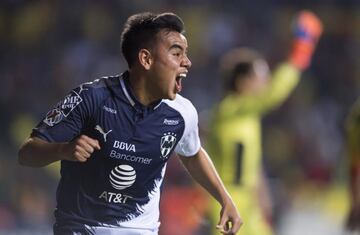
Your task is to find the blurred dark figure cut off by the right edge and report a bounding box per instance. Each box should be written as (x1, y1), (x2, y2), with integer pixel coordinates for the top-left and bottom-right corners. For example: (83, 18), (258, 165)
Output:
(346, 98), (360, 232)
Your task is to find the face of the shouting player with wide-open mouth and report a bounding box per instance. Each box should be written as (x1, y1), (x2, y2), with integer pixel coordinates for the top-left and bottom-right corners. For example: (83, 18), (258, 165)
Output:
(150, 31), (191, 99)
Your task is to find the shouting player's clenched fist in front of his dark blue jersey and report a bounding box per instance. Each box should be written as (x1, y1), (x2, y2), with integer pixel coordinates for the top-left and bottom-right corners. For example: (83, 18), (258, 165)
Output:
(63, 135), (100, 162)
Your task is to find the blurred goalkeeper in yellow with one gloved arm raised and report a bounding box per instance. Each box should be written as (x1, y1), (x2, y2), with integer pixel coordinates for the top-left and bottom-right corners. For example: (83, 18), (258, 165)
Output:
(209, 11), (322, 235)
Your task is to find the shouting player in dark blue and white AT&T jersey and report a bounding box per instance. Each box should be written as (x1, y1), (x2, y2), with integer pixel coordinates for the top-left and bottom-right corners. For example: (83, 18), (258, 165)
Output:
(19, 13), (242, 235)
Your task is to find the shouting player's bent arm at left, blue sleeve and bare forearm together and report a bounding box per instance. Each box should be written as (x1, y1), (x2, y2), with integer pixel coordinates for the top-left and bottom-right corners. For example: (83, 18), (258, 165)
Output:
(18, 80), (105, 167)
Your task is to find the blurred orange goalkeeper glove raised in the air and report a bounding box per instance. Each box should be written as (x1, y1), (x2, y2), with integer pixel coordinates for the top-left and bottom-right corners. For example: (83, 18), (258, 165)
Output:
(289, 10), (323, 70)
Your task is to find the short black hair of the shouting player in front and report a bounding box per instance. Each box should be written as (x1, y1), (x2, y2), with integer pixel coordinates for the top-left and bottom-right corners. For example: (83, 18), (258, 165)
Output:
(121, 12), (184, 68)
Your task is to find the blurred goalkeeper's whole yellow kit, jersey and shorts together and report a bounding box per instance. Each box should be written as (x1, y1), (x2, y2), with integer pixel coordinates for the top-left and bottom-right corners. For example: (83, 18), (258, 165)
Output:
(208, 63), (300, 235)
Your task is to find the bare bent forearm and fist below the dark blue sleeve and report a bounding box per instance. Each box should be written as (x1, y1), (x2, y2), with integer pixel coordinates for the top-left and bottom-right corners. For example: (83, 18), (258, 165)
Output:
(18, 135), (100, 167)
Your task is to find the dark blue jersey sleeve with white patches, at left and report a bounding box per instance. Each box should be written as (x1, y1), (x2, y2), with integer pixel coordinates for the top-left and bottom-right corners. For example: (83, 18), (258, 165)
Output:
(31, 83), (96, 142)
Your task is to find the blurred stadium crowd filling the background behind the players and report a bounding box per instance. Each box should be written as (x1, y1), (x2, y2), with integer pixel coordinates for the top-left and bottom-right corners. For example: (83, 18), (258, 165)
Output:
(0, 0), (360, 235)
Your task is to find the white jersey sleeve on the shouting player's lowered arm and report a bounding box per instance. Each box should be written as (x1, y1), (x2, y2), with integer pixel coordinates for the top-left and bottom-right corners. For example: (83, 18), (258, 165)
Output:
(175, 98), (201, 157)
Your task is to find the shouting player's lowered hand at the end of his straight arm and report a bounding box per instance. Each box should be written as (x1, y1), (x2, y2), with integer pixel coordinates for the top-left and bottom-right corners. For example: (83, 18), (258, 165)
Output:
(216, 199), (243, 235)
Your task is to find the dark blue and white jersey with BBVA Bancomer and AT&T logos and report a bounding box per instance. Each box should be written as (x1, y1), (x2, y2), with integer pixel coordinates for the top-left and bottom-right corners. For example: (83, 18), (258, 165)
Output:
(32, 72), (200, 231)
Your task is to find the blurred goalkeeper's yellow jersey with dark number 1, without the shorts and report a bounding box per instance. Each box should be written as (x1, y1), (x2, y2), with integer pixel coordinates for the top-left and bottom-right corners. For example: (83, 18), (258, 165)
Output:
(208, 63), (300, 187)
